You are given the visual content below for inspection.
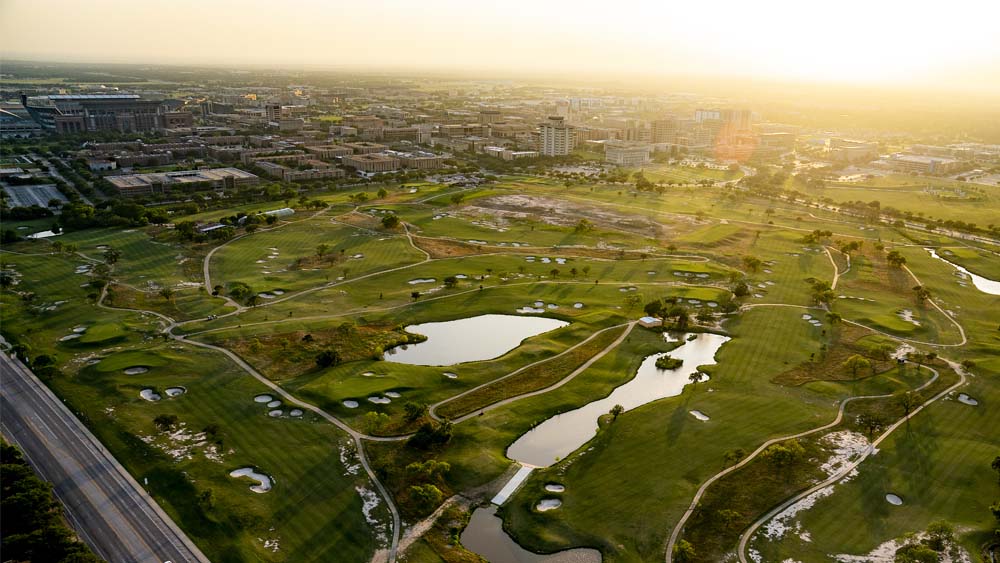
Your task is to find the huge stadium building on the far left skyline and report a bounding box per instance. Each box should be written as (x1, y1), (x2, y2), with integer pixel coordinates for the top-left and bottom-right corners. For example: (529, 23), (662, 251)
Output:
(21, 94), (166, 133)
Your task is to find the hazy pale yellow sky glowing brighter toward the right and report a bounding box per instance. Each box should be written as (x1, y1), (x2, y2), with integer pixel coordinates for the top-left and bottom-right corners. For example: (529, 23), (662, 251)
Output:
(0, 0), (1000, 91)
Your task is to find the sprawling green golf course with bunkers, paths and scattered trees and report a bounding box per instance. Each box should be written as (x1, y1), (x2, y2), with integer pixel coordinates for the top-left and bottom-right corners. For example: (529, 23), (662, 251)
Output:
(0, 171), (1000, 562)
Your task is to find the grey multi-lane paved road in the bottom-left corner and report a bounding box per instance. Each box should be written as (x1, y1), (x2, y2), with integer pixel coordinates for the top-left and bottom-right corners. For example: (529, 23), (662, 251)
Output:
(0, 353), (208, 563)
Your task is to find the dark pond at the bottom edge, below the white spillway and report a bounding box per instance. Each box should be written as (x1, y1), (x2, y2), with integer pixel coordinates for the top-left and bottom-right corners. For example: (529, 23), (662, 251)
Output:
(461, 506), (601, 563)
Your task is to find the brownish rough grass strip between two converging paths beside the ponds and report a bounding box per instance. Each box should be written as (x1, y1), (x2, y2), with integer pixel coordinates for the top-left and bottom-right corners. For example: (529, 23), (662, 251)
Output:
(436, 327), (625, 419)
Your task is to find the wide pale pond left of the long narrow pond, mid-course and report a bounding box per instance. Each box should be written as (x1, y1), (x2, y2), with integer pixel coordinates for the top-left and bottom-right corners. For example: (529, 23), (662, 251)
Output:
(385, 315), (569, 366)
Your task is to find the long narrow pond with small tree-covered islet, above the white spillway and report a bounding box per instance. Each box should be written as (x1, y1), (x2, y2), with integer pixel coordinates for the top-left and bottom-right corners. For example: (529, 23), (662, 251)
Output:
(507, 333), (729, 467)
